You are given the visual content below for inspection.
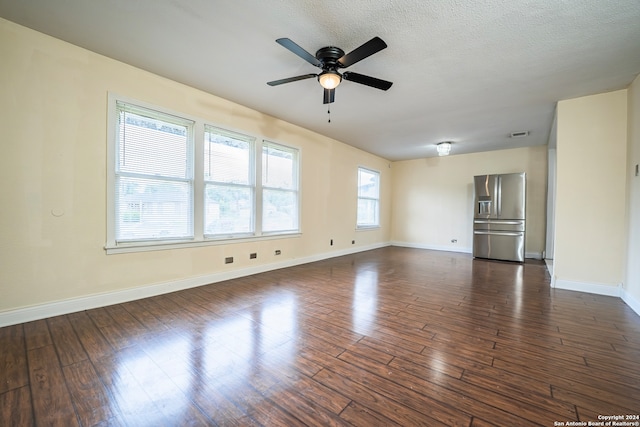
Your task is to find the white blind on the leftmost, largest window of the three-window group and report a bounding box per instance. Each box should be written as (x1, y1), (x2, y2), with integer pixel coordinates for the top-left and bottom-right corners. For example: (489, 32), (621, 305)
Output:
(114, 102), (193, 242)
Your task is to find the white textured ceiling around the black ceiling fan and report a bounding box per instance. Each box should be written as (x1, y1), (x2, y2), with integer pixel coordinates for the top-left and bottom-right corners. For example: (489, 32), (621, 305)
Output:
(0, 0), (640, 160)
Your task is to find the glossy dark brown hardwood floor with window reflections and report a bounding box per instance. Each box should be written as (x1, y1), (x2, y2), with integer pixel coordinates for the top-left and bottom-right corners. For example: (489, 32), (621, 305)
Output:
(0, 247), (640, 427)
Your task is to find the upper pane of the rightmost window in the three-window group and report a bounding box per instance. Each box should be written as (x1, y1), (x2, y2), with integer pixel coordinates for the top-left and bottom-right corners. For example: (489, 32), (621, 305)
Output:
(262, 143), (297, 190)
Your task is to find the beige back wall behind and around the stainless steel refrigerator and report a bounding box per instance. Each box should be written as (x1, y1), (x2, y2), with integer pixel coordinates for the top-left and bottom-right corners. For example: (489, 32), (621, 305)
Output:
(391, 146), (547, 257)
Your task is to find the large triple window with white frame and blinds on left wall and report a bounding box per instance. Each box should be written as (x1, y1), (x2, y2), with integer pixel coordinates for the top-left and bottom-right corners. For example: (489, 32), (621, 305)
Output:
(106, 95), (300, 253)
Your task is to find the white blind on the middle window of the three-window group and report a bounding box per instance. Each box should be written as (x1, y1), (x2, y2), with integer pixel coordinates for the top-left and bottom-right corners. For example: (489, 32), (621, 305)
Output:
(204, 126), (255, 237)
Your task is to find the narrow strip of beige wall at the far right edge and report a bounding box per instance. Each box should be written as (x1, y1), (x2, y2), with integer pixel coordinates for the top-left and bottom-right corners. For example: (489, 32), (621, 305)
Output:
(624, 76), (640, 306)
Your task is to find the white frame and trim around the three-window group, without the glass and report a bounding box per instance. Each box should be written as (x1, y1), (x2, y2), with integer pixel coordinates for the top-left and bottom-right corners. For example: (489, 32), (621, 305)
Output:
(104, 92), (302, 254)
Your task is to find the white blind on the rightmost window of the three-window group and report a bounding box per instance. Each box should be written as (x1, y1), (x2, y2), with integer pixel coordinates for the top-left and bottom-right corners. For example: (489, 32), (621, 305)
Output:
(262, 141), (299, 233)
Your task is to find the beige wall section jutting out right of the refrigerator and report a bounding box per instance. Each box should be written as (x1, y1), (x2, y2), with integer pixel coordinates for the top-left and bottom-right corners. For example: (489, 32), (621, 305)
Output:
(554, 90), (627, 287)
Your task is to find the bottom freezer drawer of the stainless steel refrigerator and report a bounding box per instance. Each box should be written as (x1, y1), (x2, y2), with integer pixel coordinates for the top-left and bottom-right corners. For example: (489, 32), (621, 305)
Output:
(473, 230), (524, 262)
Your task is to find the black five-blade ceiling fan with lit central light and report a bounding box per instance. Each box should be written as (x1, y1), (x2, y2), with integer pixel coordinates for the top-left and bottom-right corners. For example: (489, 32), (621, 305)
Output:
(267, 37), (393, 104)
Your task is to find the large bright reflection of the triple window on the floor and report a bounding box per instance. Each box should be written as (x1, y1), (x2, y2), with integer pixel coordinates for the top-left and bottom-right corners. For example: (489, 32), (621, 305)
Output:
(112, 292), (298, 426)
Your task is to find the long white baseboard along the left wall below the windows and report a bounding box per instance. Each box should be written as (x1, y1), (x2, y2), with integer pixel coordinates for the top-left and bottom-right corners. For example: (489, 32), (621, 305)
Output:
(0, 243), (389, 327)
